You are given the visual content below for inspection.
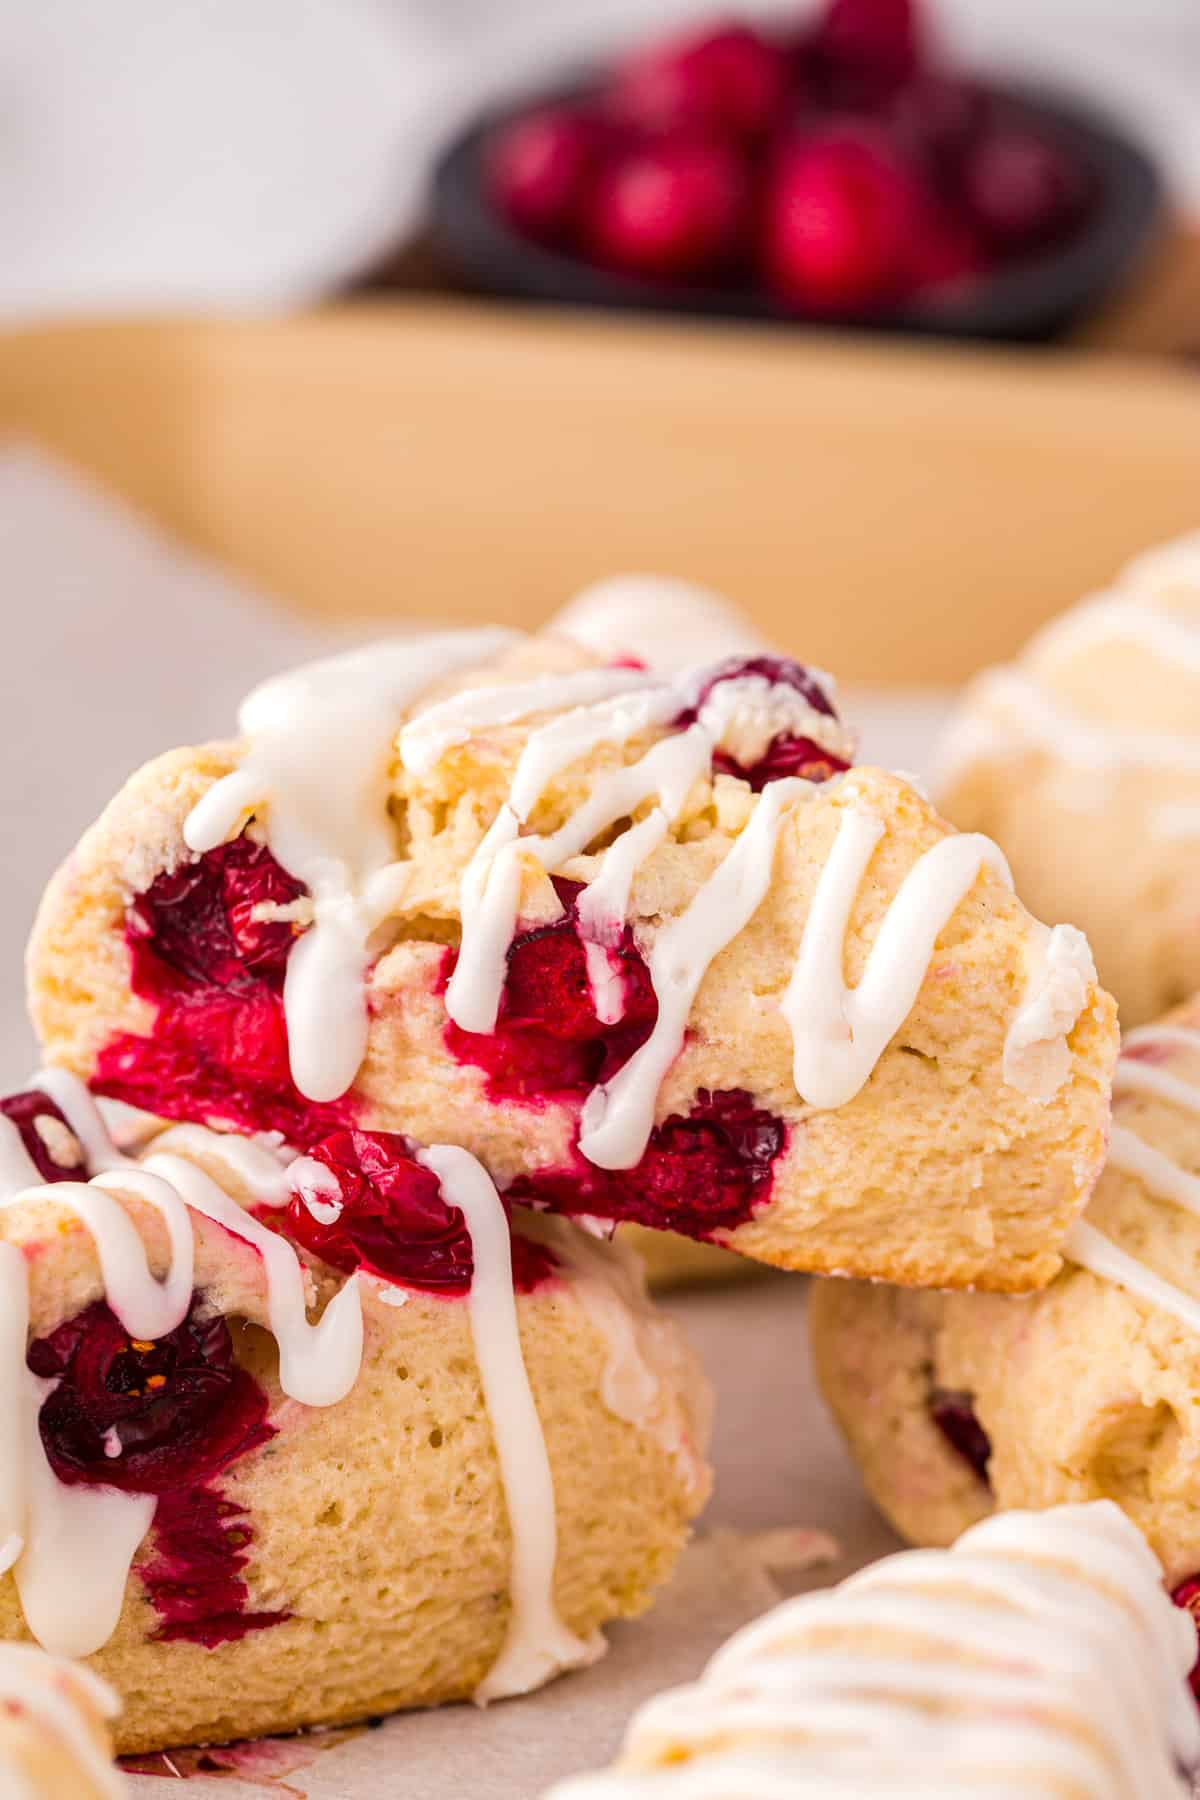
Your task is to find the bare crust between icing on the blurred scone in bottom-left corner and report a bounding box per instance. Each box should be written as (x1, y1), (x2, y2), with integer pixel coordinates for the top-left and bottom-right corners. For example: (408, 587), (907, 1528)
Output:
(0, 1645), (113, 1800)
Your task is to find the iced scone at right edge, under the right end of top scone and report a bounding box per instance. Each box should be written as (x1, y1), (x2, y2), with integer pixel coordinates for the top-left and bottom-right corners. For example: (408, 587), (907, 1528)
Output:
(811, 1001), (1200, 1586)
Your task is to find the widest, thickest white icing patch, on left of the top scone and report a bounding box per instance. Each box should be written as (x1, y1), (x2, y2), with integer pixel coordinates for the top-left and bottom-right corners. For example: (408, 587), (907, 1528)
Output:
(184, 630), (513, 1100)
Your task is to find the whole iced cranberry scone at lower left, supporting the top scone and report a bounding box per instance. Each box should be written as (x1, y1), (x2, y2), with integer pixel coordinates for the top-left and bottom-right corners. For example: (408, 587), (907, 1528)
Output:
(0, 1071), (709, 1751)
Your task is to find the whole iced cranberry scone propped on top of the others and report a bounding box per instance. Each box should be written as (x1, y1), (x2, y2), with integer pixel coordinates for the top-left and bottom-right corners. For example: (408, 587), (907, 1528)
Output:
(29, 604), (1115, 1291)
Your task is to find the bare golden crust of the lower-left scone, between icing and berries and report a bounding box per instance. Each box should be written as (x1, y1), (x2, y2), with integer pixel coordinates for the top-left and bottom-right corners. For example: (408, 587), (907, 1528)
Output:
(0, 1156), (709, 1753)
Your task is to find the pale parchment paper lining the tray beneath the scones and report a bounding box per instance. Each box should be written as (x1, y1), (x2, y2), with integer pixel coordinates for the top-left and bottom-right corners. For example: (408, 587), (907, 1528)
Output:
(0, 450), (946, 1800)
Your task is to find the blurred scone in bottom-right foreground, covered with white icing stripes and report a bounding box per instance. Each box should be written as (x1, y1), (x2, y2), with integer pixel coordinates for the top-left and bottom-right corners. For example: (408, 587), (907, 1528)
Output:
(547, 1501), (1200, 1800)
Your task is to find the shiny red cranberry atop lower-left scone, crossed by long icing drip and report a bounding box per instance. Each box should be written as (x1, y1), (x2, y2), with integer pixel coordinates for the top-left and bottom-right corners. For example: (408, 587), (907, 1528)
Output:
(288, 1130), (556, 1298)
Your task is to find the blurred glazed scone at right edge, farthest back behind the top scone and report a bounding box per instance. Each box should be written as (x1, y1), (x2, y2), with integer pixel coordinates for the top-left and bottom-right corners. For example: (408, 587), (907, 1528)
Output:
(937, 535), (1200, 1028)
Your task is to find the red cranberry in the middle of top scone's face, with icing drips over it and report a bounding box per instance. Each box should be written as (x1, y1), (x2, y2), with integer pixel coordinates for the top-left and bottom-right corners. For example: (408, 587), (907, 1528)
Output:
(443, 880), (658, 1105)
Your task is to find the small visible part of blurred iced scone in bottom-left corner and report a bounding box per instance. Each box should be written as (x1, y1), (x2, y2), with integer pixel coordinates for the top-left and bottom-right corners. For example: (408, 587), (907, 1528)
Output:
(0, 1643), (126, 1800)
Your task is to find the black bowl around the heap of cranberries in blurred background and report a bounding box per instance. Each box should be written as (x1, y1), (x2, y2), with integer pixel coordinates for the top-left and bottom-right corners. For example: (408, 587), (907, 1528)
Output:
(432, 85), (1164, 342)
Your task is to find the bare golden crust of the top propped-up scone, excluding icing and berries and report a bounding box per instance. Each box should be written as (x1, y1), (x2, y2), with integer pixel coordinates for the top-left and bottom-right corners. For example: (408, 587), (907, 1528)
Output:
(29, 646), (1115, 1291)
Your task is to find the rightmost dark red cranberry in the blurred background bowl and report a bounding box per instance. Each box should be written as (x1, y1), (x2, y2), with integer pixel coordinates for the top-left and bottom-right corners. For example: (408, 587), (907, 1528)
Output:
(961, 121), (1088, 256)
